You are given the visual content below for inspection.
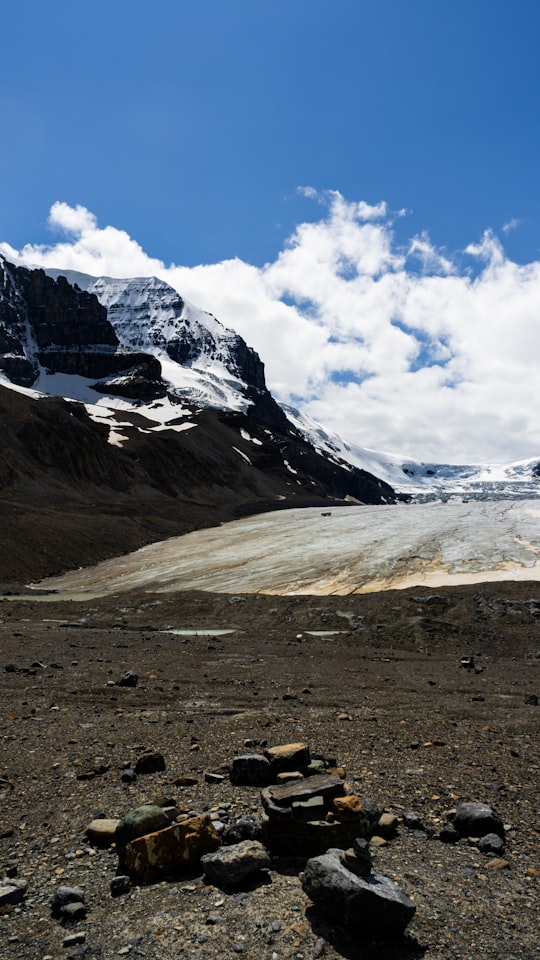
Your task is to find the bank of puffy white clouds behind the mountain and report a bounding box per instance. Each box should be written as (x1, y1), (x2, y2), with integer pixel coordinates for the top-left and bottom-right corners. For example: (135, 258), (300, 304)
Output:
(0, 188), (540, 463)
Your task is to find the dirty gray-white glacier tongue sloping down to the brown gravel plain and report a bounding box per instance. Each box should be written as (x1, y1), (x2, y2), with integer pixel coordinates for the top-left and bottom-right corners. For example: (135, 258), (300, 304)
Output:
(39, 500), (540, 595)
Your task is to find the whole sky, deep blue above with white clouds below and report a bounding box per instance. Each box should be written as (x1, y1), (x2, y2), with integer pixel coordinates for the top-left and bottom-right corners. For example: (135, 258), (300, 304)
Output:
(0, 0), (540, 460)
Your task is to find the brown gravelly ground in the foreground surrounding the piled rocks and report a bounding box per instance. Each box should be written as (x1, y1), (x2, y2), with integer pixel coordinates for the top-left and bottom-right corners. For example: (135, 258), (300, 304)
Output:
(0, 582), (540, 960)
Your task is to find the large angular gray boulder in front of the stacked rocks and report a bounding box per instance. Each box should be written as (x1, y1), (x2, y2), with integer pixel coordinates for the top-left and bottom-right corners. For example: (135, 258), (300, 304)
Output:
(302, 849), (416, 939)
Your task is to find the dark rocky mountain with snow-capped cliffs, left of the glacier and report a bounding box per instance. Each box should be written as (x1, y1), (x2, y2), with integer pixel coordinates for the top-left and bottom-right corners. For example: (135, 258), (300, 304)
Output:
(0, 257), (396, 580)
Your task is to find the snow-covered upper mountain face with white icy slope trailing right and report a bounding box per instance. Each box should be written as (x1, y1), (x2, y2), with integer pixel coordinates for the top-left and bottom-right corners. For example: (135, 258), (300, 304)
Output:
(0, 257), (540, 510)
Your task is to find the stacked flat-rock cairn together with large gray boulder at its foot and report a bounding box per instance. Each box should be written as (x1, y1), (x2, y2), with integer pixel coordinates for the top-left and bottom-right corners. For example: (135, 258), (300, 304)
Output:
(226, 743), (416, 938)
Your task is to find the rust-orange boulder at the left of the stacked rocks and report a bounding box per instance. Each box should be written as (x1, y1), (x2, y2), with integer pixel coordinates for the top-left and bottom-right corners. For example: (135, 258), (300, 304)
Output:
(124, 815), (220, 882)
